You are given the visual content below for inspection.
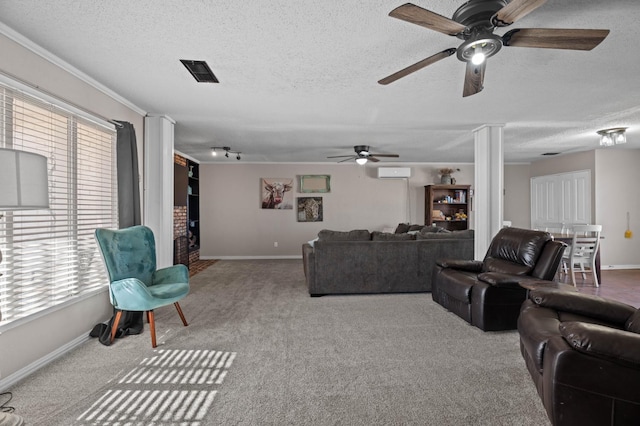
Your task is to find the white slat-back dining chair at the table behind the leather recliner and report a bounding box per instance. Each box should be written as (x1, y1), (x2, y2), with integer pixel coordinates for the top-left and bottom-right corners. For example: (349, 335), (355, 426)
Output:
(563, 225), (602, 287)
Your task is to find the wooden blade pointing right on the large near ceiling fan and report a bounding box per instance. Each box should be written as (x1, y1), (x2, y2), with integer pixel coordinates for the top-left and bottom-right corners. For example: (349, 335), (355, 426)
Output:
(502, 28), (609, 50)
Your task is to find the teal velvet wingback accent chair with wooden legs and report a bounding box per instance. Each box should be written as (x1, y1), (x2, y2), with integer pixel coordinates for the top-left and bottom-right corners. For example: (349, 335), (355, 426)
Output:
(95, 225), (189, 348)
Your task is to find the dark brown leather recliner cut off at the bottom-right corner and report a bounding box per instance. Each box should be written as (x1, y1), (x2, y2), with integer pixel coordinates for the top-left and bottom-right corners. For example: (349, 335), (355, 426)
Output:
(518, 289), (640, 426)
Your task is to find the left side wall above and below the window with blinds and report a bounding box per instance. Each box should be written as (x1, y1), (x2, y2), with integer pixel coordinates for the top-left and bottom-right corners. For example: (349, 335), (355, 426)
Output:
(0, 34), (143, 389)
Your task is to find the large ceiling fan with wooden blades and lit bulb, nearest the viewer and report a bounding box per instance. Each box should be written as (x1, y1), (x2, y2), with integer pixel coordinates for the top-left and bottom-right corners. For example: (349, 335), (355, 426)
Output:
(378, 0), (609, 97)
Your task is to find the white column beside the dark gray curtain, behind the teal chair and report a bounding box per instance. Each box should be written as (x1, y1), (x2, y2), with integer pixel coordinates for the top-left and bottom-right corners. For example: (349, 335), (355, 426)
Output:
(143, 116), (175, 268)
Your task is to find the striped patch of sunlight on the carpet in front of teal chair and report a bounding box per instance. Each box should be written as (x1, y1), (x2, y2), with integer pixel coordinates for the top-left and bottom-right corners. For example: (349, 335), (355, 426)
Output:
(77, 349), (236, 426)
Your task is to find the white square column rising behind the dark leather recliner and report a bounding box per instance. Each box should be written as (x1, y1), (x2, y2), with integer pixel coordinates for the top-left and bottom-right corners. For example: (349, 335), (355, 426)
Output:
(473, 124), (504, 260)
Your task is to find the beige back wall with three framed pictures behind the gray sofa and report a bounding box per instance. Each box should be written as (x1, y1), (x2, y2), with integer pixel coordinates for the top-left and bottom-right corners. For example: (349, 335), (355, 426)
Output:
(200, 161), (474, 259)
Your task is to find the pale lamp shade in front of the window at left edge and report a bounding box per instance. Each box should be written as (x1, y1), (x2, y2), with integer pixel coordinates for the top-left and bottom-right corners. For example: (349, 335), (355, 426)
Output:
(0, 148), (49, 211)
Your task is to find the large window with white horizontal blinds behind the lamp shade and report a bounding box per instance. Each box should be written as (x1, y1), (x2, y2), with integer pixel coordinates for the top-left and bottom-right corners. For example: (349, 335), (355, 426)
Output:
(0, 80), (118, 325)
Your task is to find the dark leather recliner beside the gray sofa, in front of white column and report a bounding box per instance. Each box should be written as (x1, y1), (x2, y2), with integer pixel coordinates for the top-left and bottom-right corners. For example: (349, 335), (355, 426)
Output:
(431, 228), (566, 331)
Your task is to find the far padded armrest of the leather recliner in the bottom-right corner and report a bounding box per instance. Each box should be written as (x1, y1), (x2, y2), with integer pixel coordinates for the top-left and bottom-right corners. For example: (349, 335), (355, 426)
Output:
(529, 289), (636, 328)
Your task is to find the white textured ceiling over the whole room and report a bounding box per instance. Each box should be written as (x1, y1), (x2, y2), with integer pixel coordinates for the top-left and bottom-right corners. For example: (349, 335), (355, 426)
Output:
(0, 0), (640, 164)
